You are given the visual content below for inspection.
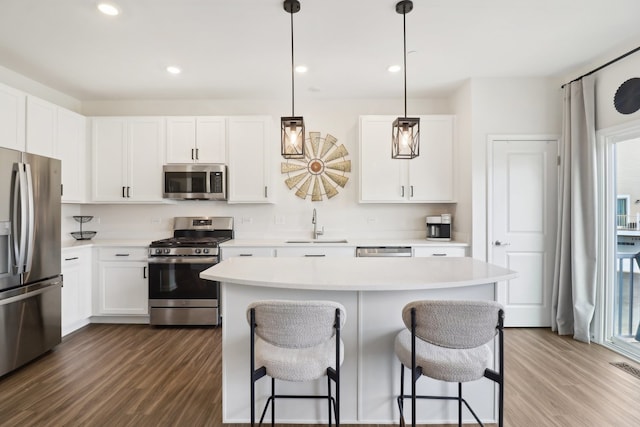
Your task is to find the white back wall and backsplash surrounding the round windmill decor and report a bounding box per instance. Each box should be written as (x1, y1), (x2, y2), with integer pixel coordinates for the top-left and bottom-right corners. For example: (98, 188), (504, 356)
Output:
(63, 98), (460, 244)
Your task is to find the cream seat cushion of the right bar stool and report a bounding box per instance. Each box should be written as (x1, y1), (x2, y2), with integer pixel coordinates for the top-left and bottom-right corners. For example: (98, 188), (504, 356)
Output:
(395, 329), (493, 382)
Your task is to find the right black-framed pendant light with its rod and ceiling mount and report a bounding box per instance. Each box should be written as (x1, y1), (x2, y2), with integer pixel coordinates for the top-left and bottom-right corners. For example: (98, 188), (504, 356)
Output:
(391, 0), (420, 159)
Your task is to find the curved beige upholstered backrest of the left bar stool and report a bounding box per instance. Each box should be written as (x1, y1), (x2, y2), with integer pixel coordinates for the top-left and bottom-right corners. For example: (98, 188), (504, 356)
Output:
(247, 300), (346, 348)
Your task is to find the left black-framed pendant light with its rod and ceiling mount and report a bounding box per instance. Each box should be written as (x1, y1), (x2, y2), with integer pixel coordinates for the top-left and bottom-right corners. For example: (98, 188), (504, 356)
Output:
(280, 0), (305, 159)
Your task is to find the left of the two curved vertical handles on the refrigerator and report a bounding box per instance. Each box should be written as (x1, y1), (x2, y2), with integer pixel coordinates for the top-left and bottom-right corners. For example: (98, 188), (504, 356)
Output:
(11, 163), (27, 274)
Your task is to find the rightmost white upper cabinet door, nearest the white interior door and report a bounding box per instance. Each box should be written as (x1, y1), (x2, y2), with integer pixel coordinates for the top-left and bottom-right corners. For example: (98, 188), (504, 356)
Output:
(408, 116), (454, 202)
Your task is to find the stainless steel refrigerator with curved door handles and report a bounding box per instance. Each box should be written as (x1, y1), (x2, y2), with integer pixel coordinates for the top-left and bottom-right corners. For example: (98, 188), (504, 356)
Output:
(0, 148), (62, 376)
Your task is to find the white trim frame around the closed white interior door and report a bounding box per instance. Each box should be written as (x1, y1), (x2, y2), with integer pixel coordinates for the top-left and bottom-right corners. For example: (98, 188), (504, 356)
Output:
(485, 134), (561, 324)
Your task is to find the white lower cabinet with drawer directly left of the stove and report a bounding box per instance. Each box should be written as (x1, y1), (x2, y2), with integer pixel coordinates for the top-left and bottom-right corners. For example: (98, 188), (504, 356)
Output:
(94, 247), (149, 316)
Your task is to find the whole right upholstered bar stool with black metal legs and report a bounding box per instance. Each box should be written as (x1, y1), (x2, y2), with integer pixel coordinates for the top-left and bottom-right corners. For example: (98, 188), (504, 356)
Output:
(395, 300), (504, 427)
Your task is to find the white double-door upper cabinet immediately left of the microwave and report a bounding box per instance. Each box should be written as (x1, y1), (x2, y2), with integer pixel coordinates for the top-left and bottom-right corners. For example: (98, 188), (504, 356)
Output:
(92, 117), (165, 203)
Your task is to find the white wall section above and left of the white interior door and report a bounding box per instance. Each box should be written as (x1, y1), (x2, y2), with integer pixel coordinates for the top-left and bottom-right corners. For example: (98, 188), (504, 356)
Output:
(461, 77), (562, 260)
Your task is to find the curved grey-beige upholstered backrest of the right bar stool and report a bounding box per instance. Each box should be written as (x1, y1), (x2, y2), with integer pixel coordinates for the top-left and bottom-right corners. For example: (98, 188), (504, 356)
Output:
(402, 300), (502, 348)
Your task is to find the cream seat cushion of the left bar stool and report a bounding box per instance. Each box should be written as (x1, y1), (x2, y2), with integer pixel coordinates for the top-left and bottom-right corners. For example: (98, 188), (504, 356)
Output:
(255, 336), (344, 382)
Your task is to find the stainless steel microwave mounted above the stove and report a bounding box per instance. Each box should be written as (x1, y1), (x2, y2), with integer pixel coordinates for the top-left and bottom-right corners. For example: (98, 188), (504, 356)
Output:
(162, 163), (227, 200)
